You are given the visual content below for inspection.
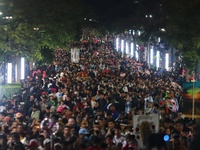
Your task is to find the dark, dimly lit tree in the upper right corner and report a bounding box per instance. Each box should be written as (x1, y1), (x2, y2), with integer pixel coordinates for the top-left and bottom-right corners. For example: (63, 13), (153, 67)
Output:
(165, 0), (200, 70)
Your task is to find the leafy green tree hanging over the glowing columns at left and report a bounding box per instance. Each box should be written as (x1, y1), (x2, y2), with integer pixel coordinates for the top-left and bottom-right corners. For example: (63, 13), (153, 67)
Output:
(0, 0), (84, 59)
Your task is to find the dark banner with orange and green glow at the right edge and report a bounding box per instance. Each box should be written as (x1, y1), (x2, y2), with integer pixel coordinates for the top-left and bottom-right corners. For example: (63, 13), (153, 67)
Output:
(182, 82), (200, 118)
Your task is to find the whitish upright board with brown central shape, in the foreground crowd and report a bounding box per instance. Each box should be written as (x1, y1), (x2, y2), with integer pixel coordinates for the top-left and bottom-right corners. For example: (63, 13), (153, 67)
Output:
(133, 114), (159, 149)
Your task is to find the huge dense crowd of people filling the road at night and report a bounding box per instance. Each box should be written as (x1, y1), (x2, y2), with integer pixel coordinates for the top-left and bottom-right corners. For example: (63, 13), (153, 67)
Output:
(0, 35), (199, 150)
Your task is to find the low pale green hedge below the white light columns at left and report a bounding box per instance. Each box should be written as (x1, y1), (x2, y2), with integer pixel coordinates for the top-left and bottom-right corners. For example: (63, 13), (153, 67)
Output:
(0, 83), (21, 100)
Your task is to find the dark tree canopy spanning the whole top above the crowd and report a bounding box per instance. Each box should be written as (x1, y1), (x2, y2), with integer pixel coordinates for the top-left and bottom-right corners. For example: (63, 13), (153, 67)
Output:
(0, 0), (200, 69)
